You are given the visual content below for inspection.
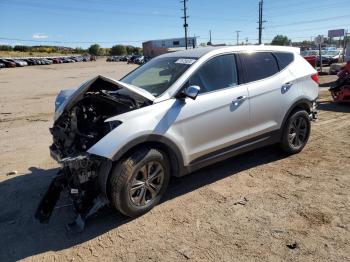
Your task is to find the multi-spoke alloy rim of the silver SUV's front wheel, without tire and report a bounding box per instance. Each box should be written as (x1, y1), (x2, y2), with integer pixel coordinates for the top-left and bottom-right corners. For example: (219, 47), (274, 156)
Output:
(129, 161), (164, 206)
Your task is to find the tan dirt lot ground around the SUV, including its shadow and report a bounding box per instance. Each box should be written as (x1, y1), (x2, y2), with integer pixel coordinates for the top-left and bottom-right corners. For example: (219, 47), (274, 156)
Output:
(0, 61), (350, 261)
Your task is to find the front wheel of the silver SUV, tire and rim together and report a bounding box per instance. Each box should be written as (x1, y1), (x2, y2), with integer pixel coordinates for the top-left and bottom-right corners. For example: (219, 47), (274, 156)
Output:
(109, 147), (170, 217)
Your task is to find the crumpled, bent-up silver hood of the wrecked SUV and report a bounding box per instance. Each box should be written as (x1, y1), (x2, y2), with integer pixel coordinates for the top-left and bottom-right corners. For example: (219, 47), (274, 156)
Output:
(54, 75), (156, 121)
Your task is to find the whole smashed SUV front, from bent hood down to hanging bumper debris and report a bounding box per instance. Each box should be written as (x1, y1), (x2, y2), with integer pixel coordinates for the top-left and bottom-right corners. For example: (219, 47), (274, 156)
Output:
(35, 76), (153, 232)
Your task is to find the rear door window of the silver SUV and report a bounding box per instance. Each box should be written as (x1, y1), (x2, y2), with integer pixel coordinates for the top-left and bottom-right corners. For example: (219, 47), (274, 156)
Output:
(240, 52), (279, 83)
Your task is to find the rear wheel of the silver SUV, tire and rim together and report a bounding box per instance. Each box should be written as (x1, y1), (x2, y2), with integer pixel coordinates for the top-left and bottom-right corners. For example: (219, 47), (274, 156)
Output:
(280, 109), (311, 154)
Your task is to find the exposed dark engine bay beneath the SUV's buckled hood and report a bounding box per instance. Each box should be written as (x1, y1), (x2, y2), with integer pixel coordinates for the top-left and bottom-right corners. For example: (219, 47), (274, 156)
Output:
(50, 78), (150, 160)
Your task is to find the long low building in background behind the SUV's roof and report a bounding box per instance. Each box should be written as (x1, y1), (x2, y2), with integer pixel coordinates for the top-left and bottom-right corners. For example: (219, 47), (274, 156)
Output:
(142, 37), (197, 58)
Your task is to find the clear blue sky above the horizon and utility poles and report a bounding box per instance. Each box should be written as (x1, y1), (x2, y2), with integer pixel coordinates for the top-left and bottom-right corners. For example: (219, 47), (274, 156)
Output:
(0, 0), (350, 48)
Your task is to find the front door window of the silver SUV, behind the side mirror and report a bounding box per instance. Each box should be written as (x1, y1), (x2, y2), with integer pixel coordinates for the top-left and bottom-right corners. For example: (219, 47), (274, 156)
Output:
(188, 54), (238, 93)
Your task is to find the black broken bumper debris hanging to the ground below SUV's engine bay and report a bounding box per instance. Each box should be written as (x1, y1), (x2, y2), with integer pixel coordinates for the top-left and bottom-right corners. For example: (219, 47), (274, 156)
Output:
(35, 154), (111, 232)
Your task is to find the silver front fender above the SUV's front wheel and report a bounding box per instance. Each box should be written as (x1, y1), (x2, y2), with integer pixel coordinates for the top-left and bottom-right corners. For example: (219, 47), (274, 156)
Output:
(88, 100), (184, 166)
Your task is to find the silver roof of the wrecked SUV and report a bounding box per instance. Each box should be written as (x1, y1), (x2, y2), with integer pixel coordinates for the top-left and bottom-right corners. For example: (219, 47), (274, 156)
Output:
(161, 45), (300, 58)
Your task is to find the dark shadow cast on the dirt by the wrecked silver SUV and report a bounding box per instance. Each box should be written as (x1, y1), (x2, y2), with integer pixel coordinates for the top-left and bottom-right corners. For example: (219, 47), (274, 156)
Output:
(0, 147), (284, 261)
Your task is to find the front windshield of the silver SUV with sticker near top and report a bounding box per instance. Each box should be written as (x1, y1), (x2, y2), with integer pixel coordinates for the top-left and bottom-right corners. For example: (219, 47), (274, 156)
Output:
(120, 57), (196, 97)
